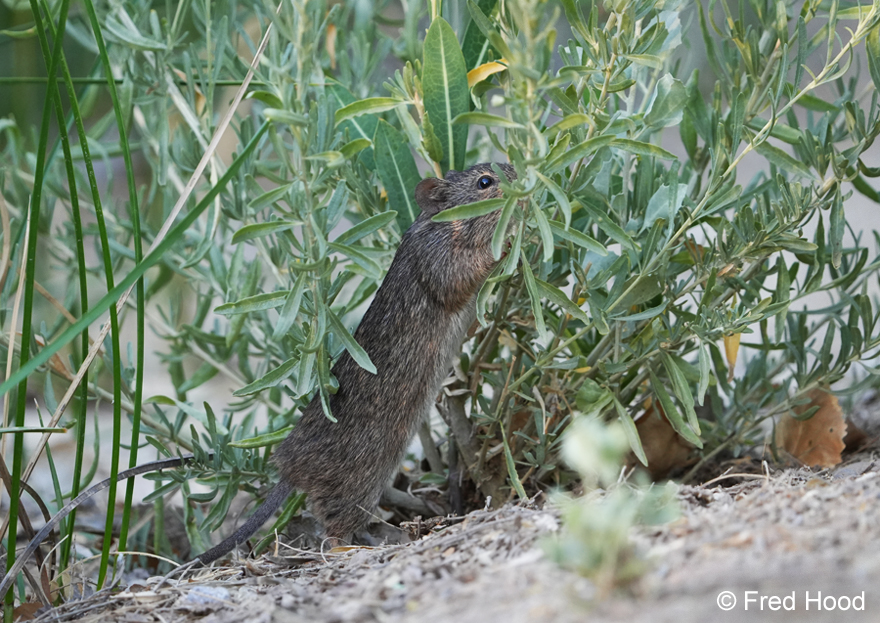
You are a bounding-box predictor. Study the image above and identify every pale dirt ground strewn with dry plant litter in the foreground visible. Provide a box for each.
[25,450,880,623]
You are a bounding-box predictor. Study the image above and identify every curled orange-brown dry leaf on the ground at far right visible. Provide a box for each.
[776,389,846,467]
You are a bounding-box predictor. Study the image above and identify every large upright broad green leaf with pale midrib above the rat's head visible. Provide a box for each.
[422,17,470,173]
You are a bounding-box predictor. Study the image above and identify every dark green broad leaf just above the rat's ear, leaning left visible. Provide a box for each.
[373,119,422,231]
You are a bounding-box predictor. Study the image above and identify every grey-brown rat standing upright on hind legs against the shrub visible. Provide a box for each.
[199,163,516,564]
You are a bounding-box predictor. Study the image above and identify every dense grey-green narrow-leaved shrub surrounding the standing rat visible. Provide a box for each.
[0,0,880,604]
